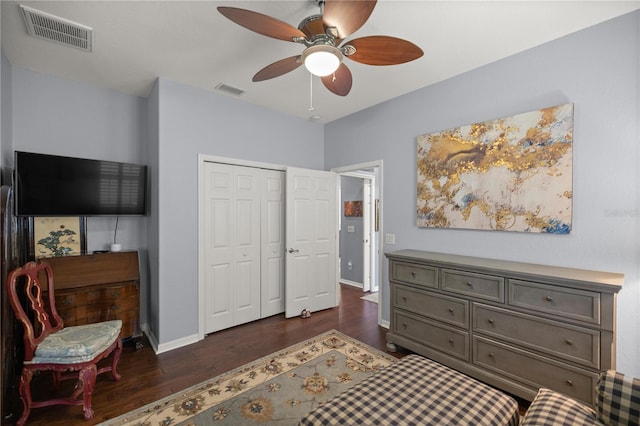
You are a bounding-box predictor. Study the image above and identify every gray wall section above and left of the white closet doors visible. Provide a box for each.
[150,78,324,343]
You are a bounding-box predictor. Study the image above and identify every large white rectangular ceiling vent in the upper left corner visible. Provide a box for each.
[20,5,93,52]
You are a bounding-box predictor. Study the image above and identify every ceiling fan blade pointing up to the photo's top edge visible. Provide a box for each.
[322,0,377,38]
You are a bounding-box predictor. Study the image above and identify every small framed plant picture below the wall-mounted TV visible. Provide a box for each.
[32,216,87,260]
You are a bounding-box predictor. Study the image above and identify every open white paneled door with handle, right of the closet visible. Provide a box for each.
[285,167,338,318]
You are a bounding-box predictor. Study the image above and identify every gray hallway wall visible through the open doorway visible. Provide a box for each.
[340,176,364,284]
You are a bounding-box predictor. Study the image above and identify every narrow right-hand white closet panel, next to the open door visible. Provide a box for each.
[261,170,285,318]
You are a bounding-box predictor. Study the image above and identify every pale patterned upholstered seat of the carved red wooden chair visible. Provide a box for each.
[25,320,122,364]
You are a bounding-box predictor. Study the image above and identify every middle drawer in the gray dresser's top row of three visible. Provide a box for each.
[442,269,504,302]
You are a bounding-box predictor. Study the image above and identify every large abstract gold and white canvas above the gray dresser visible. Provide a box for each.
[417,104,573,234]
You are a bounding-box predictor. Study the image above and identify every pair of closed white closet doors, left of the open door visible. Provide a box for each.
[202,162,284,333]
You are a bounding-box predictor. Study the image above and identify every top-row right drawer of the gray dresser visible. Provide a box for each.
[509,280,600,324]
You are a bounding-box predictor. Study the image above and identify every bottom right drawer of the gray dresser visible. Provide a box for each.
[473,336,598,404]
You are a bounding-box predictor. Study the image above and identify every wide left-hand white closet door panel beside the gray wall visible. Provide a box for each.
[204,163,260,333]
